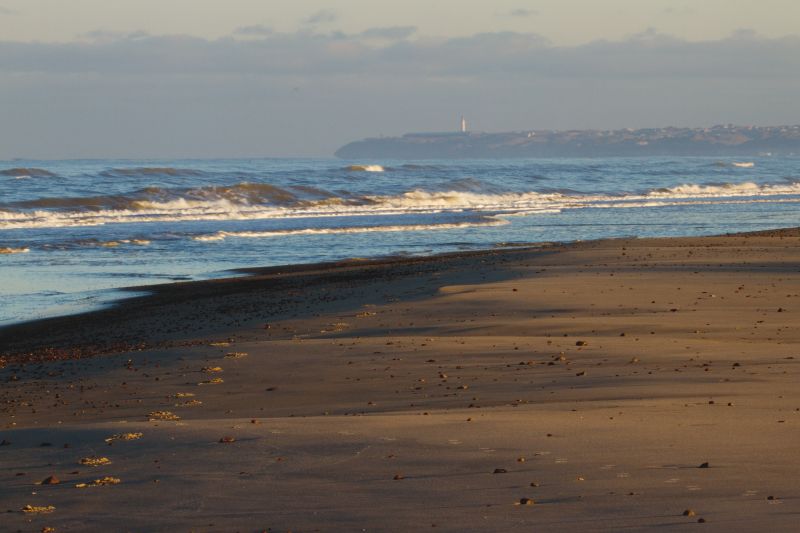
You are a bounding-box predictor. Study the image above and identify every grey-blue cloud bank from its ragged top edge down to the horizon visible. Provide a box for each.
[0,29,800,158]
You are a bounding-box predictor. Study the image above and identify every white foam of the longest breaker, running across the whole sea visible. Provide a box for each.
[6,182,800,229]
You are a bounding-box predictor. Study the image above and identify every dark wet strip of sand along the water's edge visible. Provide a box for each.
[0,227,800,361]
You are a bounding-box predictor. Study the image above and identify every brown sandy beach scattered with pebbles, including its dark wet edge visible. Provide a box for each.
[0,229,800,533]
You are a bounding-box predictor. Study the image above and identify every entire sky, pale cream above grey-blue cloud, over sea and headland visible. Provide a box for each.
[0,0,800,159]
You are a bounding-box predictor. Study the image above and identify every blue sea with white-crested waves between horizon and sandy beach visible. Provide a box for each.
[0,156,800,326]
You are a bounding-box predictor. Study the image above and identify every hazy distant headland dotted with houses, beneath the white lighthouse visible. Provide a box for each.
[336,126,800,159]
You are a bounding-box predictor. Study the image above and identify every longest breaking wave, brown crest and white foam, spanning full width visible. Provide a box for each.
[0,183,800,229]
